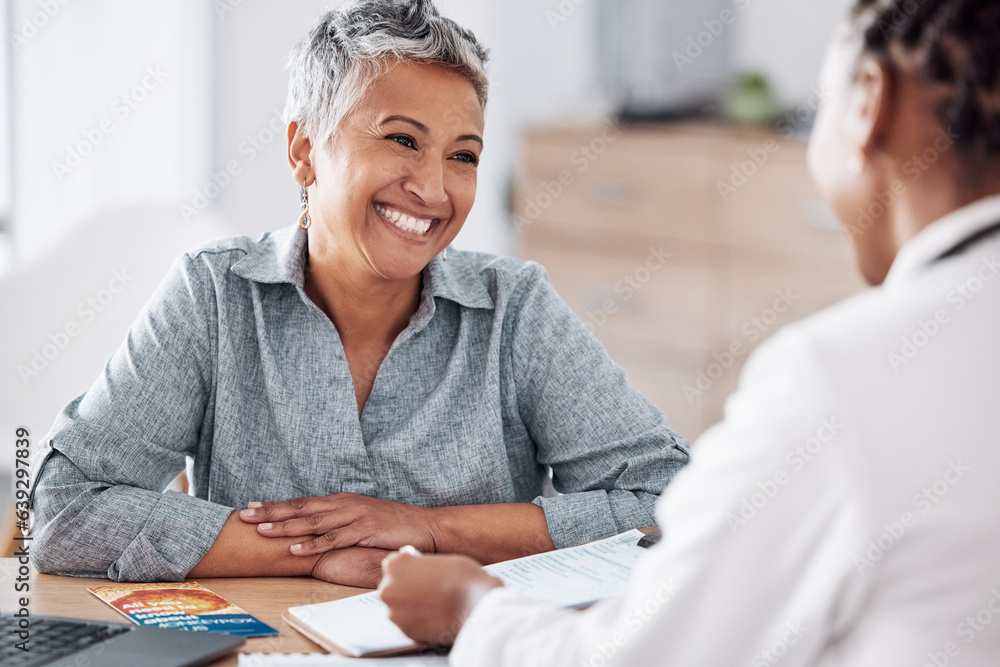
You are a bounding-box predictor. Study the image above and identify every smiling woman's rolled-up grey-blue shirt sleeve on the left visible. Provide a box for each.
[32,256,232,581]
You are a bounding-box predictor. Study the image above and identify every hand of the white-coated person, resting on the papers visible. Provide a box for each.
[378,553,503,646]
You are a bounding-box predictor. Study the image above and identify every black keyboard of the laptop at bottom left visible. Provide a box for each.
[0,616,133,667]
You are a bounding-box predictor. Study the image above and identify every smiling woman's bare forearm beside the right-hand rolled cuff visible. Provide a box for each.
[428,503,555,564]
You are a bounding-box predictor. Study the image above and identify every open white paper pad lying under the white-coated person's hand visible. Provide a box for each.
[282,530,646,657]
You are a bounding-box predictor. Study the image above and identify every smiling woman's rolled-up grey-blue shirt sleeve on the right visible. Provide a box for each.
[511,265,689,548]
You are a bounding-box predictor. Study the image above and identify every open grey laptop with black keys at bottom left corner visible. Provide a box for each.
[0,615,246,667]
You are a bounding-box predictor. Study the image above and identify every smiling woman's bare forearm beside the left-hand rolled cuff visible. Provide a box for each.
[188,512,319,577]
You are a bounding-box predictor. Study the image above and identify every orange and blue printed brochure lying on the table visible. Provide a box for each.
[87,581,280,637]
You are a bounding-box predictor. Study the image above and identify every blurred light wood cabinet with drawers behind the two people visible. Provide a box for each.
[512,126,864,439]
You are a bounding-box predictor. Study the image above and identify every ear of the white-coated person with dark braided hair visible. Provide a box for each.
[847,56,895,155]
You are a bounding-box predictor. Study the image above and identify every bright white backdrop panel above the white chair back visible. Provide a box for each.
[5,0,211,262]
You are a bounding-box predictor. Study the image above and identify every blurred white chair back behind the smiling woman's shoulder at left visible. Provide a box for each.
[0,205,231,464]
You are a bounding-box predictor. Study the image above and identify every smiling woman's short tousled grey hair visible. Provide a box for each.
[284,0,489,143]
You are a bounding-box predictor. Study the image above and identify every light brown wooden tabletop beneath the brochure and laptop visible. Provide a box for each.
[0,558,368,666]
